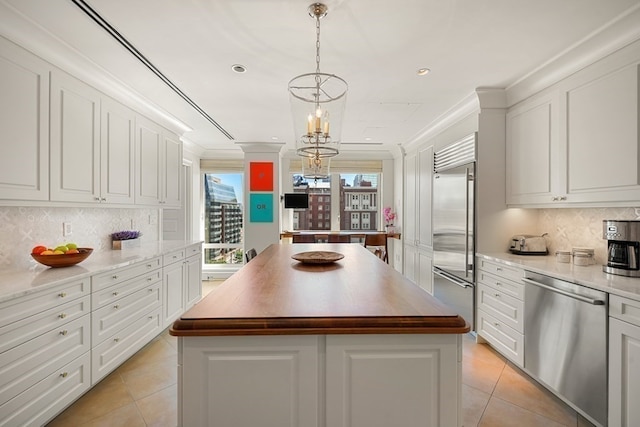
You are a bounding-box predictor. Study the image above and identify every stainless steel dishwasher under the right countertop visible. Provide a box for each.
[523,271,607,426]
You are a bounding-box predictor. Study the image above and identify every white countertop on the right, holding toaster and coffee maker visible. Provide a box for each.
[477,252,640,301]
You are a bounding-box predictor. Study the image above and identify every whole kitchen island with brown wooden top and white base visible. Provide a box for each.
[170,243,470,427]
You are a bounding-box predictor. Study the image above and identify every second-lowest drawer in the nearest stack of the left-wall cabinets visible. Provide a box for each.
[0,316,91,403]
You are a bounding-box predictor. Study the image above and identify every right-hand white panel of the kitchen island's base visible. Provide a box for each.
[326,334,462,427]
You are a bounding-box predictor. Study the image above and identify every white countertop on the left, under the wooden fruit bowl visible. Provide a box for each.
[0,240,202,302]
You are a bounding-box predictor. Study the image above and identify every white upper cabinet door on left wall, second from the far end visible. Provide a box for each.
[135,116,162,206]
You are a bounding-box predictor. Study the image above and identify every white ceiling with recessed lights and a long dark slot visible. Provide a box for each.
[0,0,640,157]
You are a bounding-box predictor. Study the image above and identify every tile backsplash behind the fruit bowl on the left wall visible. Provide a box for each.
[0,207,160,269]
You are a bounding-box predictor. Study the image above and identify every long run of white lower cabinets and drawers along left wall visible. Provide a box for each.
[0,244,202,427]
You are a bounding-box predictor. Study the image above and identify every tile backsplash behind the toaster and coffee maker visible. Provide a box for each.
[538,208,640,264]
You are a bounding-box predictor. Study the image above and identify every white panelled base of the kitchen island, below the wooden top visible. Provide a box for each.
[178,334,462,427]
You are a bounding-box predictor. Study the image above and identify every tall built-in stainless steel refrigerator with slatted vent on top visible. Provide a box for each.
[432,135,476,330]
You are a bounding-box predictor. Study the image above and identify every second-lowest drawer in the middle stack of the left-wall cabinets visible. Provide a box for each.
[91,281,162,346]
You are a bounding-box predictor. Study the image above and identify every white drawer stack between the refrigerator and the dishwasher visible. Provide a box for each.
[476,258,525,367]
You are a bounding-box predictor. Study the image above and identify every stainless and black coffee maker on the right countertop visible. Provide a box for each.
[602,220,640,277]
